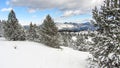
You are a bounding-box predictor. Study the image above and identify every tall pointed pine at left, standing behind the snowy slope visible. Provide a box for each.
[4,10,25,41]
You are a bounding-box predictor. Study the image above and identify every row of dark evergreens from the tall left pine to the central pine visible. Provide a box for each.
[3,10,60,48]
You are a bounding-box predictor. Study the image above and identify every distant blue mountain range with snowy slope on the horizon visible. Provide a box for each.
[56,22,96,32]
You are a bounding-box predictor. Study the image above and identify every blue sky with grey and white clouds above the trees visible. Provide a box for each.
[0,0,103,25]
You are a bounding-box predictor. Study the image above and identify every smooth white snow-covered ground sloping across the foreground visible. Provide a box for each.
[0,38,89,68]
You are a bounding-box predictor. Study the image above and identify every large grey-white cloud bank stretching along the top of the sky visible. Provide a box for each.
[9,0,103,16]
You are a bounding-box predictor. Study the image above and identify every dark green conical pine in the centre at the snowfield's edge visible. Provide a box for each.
[40,15,59,48]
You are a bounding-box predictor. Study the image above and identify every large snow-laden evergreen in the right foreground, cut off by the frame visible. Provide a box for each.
[91,0,120,68]
